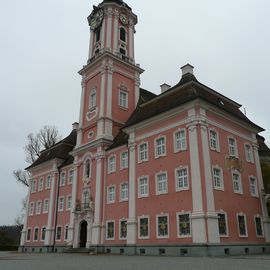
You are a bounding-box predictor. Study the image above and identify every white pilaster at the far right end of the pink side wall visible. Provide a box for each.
[253,145,270,242]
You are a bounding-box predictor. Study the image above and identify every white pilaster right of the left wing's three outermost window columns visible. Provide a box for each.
[44,173,57,246]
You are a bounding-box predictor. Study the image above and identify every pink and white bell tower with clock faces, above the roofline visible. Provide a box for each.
[77,0,143,147]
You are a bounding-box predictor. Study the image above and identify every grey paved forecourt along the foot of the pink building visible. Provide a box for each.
[0,252,270,270]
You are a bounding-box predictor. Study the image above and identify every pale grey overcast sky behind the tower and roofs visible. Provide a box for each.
[0,0,270,225]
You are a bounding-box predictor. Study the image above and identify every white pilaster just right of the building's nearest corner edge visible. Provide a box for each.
[201,123,220,243]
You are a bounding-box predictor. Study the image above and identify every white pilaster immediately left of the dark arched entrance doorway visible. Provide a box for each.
[67,165,78,246]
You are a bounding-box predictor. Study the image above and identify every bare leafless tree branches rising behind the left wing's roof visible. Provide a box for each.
[13,126,61,187]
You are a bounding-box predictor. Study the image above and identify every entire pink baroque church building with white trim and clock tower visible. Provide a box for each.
[20,0,270,256]
